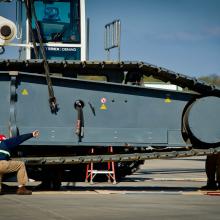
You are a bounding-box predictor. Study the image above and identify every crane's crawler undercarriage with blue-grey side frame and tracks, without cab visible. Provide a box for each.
[0,60,220,188]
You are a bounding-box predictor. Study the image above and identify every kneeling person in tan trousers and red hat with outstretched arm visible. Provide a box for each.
[0,130,40,195]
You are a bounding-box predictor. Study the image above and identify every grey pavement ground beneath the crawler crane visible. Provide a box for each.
[0,158,220,220]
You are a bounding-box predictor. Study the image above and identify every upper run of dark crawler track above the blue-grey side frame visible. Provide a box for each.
[0,60,220,97]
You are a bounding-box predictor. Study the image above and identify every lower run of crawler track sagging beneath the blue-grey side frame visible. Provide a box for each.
[13,147,220,166]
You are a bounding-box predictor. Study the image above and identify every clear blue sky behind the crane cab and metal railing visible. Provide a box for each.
[0,0,220,76]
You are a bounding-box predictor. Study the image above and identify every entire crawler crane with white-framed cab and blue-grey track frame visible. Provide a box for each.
[0,0,220,188]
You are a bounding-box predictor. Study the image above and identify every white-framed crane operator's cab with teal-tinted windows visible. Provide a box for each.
[22,0,86,60]
